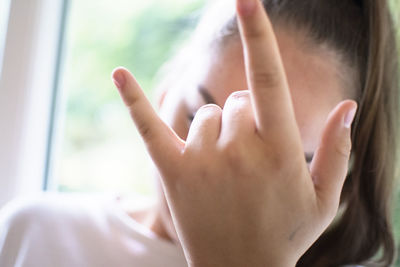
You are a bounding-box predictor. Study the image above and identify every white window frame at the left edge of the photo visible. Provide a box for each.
[0,0,67,207]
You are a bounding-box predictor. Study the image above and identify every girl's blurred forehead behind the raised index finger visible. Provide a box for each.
[188,28,349,154]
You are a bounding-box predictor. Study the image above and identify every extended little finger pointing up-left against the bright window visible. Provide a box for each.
[112,67,184,178]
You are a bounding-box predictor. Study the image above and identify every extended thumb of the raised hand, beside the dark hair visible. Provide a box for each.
[310,100,357,214]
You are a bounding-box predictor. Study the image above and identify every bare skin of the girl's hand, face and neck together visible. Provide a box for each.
[113,1,356,266]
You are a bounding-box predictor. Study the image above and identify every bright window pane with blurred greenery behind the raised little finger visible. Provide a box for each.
[53,0,204,199]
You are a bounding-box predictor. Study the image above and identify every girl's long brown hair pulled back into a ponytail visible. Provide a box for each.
[155,0,399,267]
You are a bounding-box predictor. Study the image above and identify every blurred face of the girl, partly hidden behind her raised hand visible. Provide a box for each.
[155,26,350,244]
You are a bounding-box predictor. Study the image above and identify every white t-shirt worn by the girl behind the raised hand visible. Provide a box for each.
[0,194,187,267]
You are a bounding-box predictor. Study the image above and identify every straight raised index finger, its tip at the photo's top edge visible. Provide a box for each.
[236,0,297,136]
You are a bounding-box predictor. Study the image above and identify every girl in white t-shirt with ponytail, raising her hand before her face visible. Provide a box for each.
[0,0,398,266]
